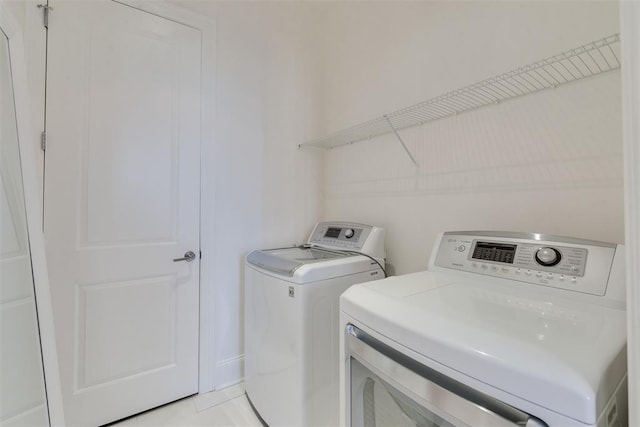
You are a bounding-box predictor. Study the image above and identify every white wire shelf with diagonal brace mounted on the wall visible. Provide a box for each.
[299,34,620,159]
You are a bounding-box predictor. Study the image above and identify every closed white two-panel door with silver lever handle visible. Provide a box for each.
[44,0,201,426]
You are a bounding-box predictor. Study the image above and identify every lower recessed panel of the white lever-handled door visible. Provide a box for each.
[76,277,176,390]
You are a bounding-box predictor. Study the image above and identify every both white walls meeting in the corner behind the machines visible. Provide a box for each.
[177,0,624,388]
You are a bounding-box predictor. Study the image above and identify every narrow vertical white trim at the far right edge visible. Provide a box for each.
[620,1,640,426]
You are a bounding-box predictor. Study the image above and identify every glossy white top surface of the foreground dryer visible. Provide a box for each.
[340,272,626,424]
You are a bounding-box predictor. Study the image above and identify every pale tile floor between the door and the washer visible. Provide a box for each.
[110,384,262,427]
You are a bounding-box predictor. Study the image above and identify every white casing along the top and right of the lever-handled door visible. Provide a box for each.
[113,0,216,393]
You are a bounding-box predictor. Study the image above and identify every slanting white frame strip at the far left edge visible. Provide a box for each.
[0,2,65,427]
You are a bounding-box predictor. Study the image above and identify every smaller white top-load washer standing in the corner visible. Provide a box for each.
[244,222,385,427]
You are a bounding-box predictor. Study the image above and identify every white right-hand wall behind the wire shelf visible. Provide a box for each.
[320,2,624,274]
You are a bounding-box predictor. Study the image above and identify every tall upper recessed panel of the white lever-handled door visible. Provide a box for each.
[81,22,180,246]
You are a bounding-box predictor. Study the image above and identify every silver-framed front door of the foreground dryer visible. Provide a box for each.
[347,325,547,427]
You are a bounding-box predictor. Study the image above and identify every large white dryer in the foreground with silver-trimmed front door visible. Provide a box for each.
[340,231,628,427]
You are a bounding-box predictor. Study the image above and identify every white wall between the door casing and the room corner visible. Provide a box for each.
[177,1,322,388]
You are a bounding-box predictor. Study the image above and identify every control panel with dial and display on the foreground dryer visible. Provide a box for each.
[432,232,616,295]
